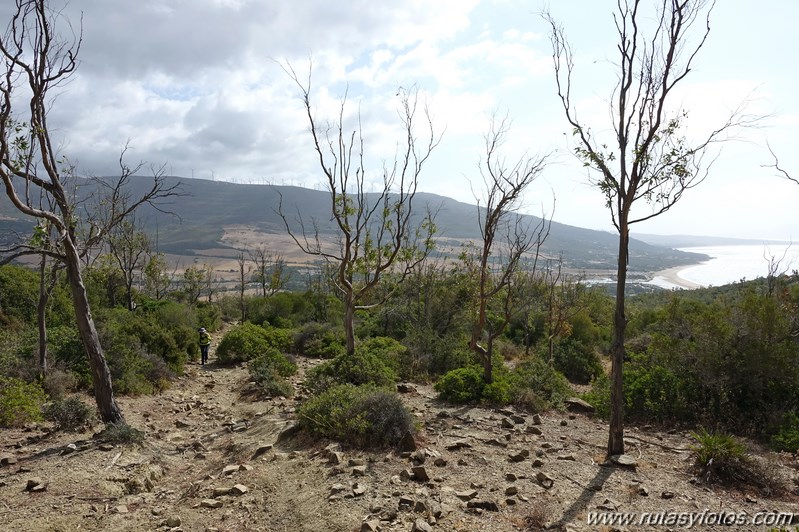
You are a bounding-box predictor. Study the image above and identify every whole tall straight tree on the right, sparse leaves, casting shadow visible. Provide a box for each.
[544,0,756,456]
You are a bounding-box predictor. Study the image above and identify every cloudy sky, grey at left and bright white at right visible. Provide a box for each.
[0,0,799,241]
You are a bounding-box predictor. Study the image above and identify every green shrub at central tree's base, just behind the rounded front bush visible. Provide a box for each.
[306,349,397,393]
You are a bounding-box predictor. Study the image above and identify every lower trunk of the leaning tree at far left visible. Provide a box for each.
[64,239,125,423]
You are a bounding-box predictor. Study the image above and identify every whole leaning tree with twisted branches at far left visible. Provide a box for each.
[0,0,178,423]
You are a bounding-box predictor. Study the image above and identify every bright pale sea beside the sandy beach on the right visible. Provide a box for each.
[650,244,799,288]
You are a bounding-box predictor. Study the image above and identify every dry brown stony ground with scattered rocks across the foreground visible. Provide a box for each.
[0,338,799,532]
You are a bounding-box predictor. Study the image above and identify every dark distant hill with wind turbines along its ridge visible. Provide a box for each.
[0,177,708,272]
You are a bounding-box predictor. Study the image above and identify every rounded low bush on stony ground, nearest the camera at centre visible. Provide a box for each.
[297,384,415,448]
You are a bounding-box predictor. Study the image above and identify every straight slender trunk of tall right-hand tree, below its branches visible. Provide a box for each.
[608,222,630,456]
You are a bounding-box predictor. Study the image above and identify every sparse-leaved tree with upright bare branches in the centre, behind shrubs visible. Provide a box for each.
[279,66,441,354]
